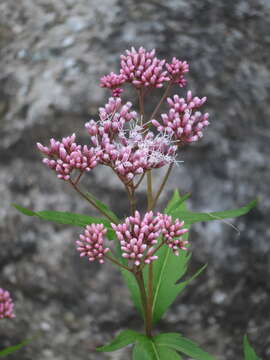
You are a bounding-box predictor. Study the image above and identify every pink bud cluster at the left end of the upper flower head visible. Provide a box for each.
[37,134,99,180]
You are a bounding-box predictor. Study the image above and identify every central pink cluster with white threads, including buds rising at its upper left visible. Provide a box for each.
[85,98,177,181]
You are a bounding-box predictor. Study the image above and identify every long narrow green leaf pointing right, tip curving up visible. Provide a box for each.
[171,200,257,225]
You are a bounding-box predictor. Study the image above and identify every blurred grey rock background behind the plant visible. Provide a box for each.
[0,0,270,360]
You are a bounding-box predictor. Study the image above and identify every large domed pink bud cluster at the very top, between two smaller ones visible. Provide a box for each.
[120,47,169,88]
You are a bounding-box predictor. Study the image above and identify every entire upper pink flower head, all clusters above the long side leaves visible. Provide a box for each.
[37,47,209,183]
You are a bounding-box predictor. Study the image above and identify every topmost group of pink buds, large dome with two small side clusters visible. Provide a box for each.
[100,47,189,97]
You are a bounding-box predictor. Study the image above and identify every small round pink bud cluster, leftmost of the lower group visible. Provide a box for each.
[76,224,110,264]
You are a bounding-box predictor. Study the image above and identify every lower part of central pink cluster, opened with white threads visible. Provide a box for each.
[92,123,177,181]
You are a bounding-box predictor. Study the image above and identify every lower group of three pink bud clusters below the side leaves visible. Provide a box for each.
[77,211,188,267]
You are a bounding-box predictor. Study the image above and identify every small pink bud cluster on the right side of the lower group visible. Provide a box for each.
[158,213,188,256]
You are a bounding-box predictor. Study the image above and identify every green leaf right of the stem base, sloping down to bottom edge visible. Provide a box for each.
[154,333,215,360]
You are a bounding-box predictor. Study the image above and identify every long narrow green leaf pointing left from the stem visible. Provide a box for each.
[13,204,115,240]
